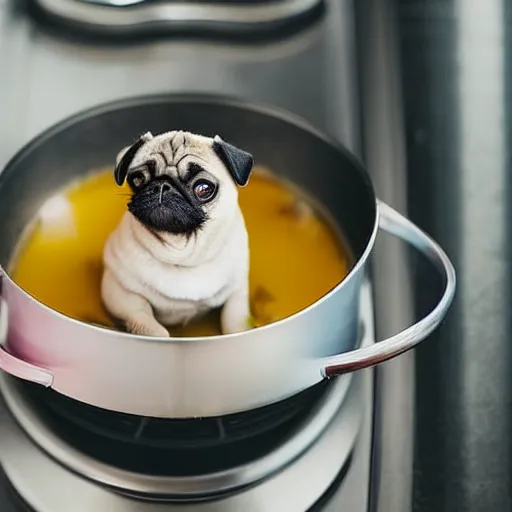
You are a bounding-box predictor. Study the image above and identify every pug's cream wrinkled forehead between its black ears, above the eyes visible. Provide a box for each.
[130,131,218,175]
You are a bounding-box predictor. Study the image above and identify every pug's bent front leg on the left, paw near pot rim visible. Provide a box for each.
[101,270,169,338]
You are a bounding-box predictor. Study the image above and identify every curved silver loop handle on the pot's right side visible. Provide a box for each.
[322,201,456,377]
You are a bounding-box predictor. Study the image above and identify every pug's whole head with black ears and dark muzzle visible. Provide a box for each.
[114,131,253,236]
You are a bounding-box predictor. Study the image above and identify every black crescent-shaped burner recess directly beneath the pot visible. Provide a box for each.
[20,381,331,477]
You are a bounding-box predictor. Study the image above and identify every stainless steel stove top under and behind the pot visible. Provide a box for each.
[0,0,414,512]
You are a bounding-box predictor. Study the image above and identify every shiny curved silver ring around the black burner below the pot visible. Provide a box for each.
[0,358,352,500]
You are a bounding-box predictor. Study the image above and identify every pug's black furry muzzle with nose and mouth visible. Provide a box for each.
[128,178,206,235]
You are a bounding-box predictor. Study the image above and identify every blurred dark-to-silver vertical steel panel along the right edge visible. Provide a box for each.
[397,0,512,512]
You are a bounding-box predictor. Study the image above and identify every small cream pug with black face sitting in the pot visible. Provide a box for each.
[101,131,254,337]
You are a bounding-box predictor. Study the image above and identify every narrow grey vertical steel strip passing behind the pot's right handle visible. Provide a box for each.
[358,0,416,512]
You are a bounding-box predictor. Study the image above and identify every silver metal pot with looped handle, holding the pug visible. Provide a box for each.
[0,95,455,418]
